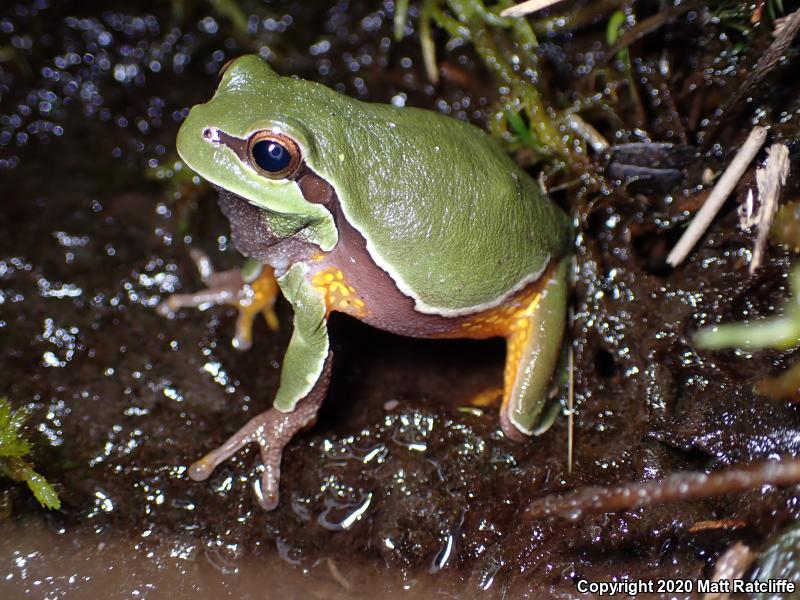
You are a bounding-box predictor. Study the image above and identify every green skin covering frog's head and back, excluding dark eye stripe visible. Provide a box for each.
[178,56,571,316]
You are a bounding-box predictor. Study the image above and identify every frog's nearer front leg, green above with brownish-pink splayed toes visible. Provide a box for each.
[189,263,333,510]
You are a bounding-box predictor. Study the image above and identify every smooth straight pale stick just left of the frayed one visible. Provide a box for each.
[667,125,767,267]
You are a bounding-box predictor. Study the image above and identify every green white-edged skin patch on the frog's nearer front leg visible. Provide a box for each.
[273,263,330,412]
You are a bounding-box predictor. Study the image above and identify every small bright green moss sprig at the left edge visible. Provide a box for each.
[0,398,61,509]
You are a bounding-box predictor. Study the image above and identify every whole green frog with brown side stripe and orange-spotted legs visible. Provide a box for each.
[164,55,573,510]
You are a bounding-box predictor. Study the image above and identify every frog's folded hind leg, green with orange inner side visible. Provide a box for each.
[500,260,568,440]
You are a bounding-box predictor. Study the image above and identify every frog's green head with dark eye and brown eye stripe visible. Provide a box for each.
[177,56,338,258]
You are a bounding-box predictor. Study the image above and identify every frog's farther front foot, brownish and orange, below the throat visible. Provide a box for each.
[157,248,279,350]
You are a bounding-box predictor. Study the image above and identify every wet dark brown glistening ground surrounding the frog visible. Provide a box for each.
[0,0,800,598]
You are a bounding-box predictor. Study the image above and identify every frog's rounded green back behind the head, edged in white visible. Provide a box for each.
[310,95,569,314]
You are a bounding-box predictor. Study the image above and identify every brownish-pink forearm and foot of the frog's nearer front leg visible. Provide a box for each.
[189,354,331,510]
